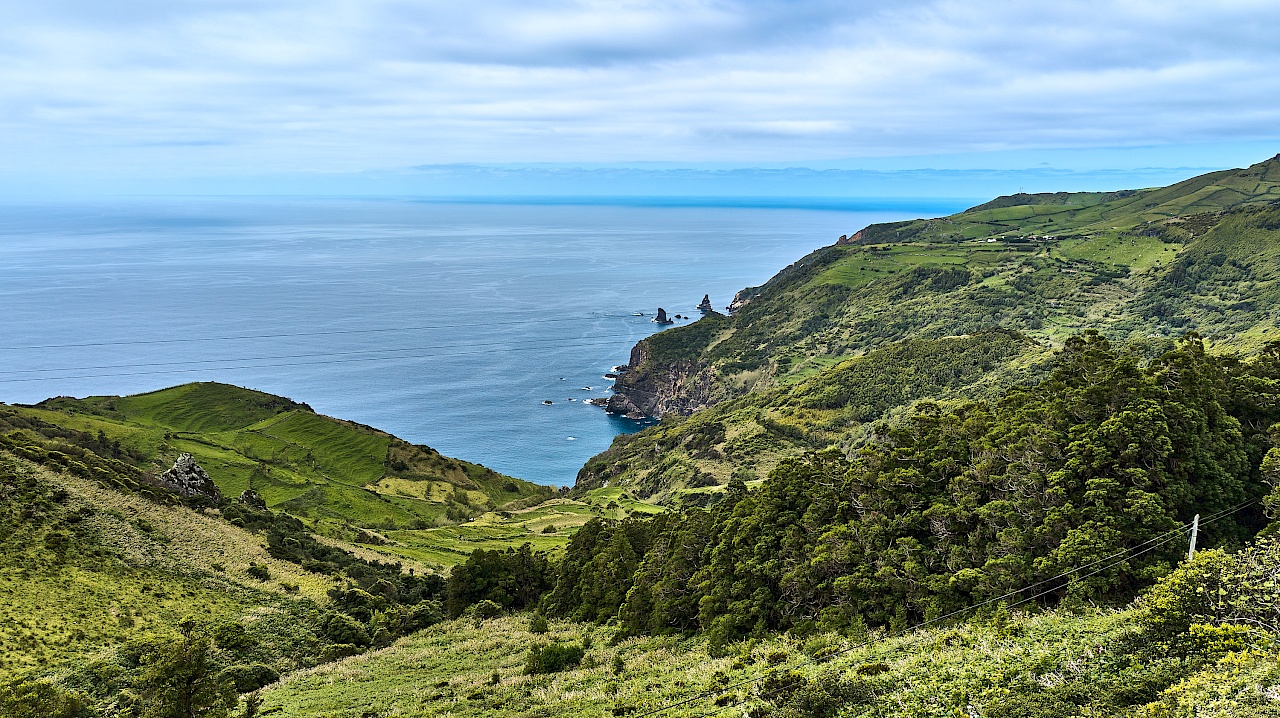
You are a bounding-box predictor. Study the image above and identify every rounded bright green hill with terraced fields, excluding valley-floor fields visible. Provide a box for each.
[13,383,549,538]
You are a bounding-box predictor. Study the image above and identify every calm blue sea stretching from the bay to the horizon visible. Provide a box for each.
[0,198,955,484]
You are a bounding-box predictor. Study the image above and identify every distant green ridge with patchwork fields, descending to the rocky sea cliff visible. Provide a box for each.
[614,151,1280,416]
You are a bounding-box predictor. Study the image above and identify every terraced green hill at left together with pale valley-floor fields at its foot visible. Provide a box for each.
[0,384,658,570]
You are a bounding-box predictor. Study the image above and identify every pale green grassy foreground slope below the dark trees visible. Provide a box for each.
[264,563,1280,718]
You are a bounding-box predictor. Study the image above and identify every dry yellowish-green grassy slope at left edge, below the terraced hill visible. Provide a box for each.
[0,452,329,678]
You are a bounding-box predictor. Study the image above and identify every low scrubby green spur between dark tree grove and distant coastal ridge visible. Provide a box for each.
[577,331,1046,502]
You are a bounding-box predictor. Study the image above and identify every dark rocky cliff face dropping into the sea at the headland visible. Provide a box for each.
[605,340,716,419]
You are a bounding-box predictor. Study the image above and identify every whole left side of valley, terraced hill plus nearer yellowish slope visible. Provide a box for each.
[0,384,662,718]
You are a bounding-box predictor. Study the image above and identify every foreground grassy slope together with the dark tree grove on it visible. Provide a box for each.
[254,335,1280,718]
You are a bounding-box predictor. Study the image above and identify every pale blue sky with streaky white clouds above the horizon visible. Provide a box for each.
[0,0,1280,196]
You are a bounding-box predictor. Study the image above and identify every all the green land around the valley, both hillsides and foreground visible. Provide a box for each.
[0,157,1280,718]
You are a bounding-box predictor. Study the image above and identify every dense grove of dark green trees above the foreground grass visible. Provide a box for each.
[449,334,1280,645]
